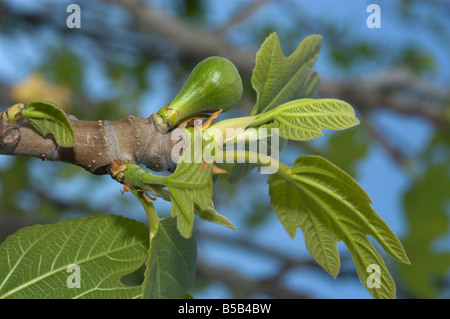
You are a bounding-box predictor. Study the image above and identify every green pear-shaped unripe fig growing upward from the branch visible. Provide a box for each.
[155,57,242,129]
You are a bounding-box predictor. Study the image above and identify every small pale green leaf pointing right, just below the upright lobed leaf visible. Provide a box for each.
[252,99,359,141]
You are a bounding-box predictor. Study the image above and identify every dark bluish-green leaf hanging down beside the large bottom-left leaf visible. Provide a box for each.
[142,217,197,299]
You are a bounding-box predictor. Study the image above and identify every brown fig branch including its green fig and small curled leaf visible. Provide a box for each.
[0,57,242,175]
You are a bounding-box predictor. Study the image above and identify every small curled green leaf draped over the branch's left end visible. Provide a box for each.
[22,100,75,147]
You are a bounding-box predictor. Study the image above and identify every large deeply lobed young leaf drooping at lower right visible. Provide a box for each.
[268,156,409,298]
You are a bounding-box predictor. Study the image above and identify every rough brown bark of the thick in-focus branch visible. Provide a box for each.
[0,116,183,175]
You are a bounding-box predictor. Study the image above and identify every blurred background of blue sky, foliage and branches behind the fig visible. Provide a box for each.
[0,0,450,298]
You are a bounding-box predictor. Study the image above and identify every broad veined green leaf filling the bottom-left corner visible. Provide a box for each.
[0,215,149,299]
